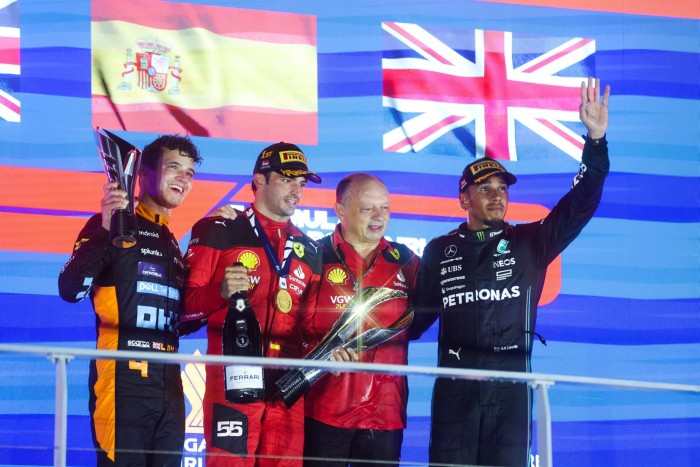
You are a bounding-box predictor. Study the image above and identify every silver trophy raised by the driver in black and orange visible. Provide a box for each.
[93,127,141,248]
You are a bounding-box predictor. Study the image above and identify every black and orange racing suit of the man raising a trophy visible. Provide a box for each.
[58,204,185,466]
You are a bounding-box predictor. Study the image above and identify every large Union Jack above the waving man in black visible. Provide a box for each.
[382,22,595,161]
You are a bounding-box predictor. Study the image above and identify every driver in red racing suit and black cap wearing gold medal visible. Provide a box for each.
[181,143,321,467]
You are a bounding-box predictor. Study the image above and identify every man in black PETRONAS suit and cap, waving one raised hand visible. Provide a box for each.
[409,78,610,466]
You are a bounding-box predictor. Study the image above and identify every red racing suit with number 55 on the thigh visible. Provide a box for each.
[182,207,321,467]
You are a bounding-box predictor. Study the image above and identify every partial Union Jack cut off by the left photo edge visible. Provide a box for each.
[0,0,20,122]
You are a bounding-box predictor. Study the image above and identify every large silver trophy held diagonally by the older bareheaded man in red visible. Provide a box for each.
[275,287,413,407]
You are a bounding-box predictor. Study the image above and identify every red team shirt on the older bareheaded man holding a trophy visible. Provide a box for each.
[304,227,419,430]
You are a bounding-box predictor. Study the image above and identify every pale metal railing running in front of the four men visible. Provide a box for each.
[0,344,700,467]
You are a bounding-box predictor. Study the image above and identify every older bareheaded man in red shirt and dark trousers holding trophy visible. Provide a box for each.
[304,173,419,467]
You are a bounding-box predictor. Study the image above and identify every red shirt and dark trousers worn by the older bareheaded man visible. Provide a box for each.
[304,230,419,466]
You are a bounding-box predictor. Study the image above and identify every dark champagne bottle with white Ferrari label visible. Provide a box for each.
[222,292,265,404]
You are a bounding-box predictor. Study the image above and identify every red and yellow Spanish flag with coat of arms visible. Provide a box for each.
[92,0,318,144]
